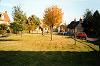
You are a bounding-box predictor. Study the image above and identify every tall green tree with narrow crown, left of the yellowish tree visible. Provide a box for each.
[12,6,27,34]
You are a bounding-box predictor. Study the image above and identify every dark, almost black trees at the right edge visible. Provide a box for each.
[83,10,100,38]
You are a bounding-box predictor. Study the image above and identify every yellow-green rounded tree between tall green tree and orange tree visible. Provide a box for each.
[26,15,40,33]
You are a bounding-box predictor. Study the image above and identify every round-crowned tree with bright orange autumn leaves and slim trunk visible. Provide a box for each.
[43,6,63,40]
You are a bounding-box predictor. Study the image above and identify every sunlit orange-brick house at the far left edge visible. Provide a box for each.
[0,11,10,25]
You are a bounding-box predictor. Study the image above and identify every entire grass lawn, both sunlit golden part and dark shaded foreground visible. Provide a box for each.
[0,34,100,66]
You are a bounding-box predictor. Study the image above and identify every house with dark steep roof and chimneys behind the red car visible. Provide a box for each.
[67,18,84,33]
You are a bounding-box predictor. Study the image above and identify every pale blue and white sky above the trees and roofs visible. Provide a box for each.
[0,0,100,24]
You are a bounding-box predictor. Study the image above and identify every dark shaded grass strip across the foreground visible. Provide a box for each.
[0,51,100,66]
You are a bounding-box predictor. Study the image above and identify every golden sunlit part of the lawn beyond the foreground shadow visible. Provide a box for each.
[0,34,99,52]
